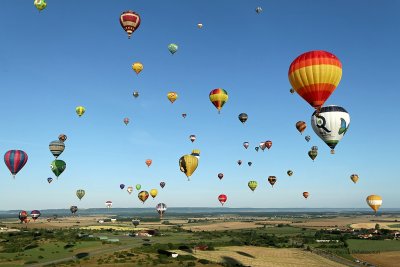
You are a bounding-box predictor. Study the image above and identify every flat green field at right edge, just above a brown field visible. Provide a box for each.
[347,239,400,253]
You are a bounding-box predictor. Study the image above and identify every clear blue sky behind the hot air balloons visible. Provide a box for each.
[0,0,400,210]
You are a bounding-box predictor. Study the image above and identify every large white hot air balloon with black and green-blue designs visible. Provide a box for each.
[311,105,350,154]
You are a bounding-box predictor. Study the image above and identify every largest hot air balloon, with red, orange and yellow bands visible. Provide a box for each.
[288,50,342,110]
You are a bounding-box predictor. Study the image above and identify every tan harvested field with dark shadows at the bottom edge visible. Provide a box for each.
[176,246,344,267]
